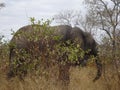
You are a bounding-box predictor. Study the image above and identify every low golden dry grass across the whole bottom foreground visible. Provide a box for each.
[0,66,120,90]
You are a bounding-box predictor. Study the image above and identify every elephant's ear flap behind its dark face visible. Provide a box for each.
[70,27,85,50]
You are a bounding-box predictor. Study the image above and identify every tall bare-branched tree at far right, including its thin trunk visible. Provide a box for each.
[85,0,120,84]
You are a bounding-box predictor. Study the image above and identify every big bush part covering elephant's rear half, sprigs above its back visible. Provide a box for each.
[9,18,53,76]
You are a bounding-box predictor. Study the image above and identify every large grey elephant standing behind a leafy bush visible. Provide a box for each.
[7,25,102,89]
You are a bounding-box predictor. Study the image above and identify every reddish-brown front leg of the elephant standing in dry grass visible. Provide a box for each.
[58,64,70,90]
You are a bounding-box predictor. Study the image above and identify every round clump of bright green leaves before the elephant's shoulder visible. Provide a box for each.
[54,40,85,64]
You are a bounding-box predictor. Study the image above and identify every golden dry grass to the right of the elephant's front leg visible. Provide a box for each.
[70,67,120,90]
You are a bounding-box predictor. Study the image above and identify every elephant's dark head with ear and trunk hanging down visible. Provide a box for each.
[70,27,102,82]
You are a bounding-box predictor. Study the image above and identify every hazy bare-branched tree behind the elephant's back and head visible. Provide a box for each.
[54,10,96,35]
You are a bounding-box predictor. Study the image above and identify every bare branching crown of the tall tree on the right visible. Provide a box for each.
[86,0,120,50]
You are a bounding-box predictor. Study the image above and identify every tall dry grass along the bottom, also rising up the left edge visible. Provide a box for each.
[0,41,120,90]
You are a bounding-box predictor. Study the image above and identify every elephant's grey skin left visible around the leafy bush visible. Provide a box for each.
[8,25,102,87]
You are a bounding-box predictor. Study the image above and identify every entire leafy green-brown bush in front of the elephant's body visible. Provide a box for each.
[9,18,89,76]
